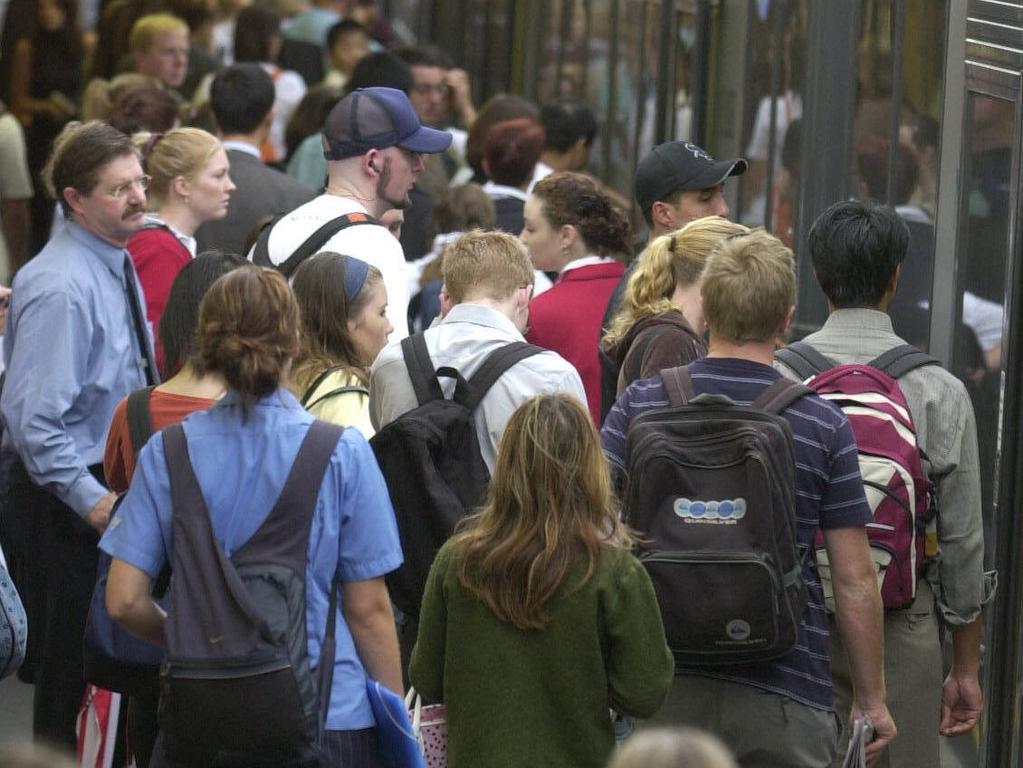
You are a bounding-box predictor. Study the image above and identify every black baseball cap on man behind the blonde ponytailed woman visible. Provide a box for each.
[635,141,749,211]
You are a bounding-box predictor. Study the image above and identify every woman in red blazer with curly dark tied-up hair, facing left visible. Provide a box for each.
[521,172,629,424]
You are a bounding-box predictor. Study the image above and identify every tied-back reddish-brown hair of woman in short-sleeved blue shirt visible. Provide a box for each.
[198,265,299,404]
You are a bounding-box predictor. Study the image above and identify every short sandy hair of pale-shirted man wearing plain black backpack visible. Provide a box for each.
[443,229,535,304]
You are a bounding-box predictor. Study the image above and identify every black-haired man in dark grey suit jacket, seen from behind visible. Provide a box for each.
[195,63,316,255]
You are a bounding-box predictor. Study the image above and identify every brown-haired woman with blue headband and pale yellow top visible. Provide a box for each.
[292,252,393,438]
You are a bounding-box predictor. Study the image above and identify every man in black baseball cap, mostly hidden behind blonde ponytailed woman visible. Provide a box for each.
[599,141,749,420]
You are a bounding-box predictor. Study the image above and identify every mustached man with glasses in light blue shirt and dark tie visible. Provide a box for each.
[0,122,157,749]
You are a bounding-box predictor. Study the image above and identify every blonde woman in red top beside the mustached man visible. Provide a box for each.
[128,128,234,359]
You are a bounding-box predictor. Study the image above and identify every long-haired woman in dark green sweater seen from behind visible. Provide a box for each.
[409,395,674,768]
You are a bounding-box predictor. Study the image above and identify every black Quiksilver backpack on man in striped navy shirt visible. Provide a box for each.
[624,367,810,666]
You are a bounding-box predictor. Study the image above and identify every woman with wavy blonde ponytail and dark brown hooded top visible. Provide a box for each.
[601,216,750,396]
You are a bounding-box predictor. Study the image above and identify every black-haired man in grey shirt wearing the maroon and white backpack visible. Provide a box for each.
[775,201,994,766]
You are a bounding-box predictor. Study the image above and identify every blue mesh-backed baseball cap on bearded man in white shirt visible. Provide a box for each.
[323,87,451,160]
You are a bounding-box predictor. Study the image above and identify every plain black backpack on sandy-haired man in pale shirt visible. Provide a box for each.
[369,333,543,618]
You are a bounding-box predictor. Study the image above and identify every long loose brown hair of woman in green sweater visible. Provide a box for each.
[452,394,632,629]
